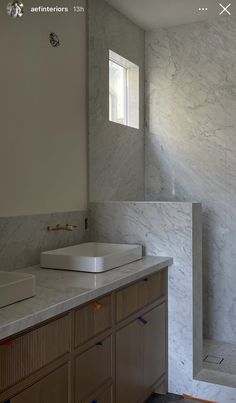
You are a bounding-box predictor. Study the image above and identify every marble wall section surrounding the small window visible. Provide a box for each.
[88,0,145,201]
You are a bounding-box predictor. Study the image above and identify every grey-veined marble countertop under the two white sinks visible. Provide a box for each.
[0,256,173,340]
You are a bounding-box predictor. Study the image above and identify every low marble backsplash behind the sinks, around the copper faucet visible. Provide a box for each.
[0,210,89,271]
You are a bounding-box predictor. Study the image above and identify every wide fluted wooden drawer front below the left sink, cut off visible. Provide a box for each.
[0,315,70,391]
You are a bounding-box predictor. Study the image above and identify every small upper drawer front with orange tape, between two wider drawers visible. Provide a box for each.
[75,295,112,347]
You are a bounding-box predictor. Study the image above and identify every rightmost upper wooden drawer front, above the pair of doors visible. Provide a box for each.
[116,270,167,322]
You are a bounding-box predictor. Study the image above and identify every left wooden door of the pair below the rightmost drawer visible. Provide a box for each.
[116,320,144,403]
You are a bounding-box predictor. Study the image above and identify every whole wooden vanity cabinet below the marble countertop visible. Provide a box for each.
[0,269,167,403]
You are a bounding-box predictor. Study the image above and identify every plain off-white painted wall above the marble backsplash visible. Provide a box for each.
[0,0,87,216]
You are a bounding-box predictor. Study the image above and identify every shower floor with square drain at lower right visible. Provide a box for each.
[203,340,236,374]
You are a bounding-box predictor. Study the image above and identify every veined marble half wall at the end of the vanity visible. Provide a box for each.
[90,202,202,400]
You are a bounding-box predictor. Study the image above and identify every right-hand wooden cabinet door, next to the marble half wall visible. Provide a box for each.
[143,303,166,388]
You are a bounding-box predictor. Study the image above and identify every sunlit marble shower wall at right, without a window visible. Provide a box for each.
[145,16,236,342]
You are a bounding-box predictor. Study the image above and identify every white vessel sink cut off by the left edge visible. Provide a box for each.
[0,271,35,308]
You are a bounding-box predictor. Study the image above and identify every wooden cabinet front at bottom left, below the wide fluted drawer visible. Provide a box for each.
[9,364,69,403]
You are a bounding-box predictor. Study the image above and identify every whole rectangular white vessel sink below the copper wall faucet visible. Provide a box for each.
[41,242,142,273]
